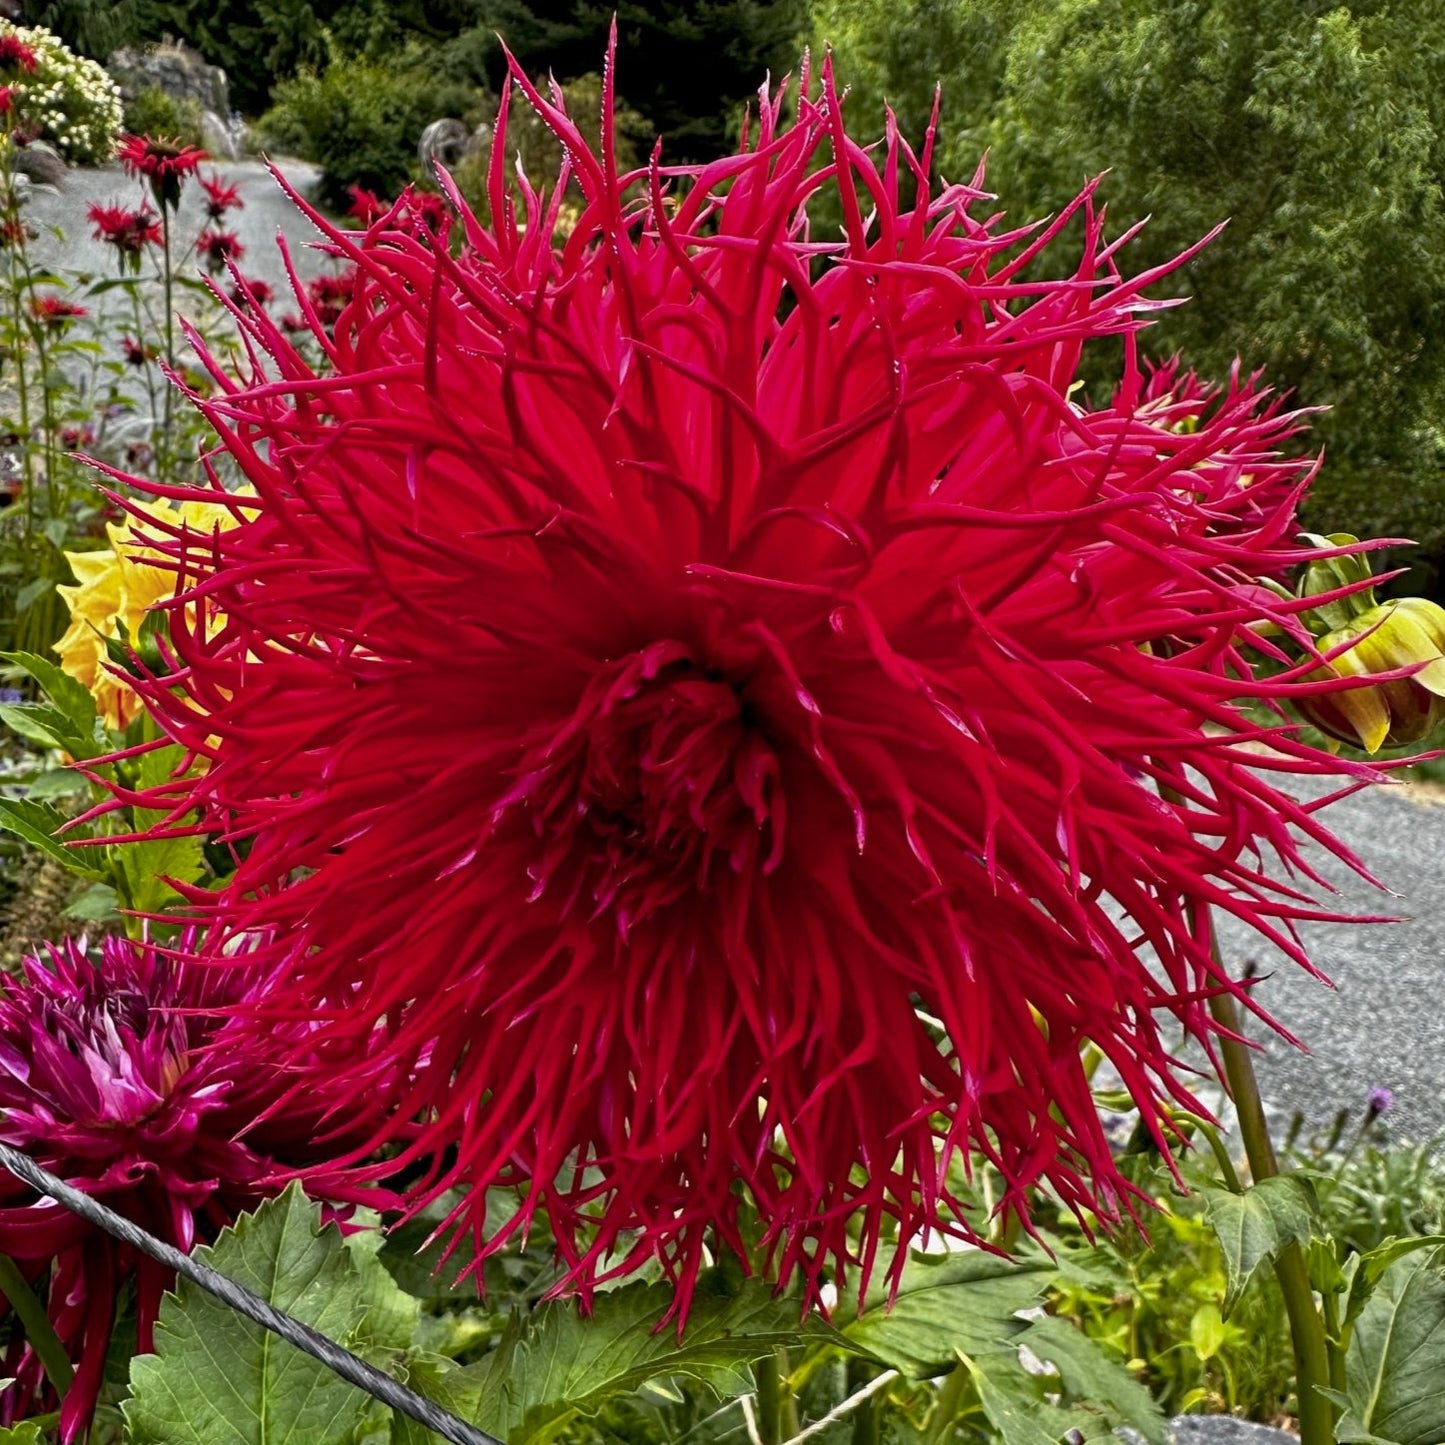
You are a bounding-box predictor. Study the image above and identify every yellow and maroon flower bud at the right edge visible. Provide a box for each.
[1299,597,1445,753]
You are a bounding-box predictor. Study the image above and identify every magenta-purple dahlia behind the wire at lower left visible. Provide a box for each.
[0,938,367,1445]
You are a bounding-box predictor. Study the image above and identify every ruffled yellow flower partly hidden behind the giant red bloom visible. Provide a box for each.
[55,501,236,730]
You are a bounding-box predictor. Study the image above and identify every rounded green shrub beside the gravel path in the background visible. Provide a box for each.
[249,42,481,208]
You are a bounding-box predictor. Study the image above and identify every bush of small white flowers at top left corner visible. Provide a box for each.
[0,22,123,165]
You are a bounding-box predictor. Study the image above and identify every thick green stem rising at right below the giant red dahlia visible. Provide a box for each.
[1209,994,1335,1445]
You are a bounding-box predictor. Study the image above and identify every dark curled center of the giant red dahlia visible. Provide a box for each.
[509,642,783,932]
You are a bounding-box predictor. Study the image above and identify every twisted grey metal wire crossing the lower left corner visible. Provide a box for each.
[0,1144,503,1445]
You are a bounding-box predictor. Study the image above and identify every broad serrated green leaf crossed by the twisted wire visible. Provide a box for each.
[121,1183,371,1445]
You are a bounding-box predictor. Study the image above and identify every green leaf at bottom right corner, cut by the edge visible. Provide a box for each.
[1335,1247,1445,1445]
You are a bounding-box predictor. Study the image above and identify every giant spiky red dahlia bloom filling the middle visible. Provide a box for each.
[127,62,1374,1311]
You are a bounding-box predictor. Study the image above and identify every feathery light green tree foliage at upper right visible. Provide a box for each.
[815,0,1445,590]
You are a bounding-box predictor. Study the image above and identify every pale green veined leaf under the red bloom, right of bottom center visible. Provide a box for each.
[841,1250,1056,1380]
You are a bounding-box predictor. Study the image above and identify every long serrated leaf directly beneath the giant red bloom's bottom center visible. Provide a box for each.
[465,1280,832,1445]
